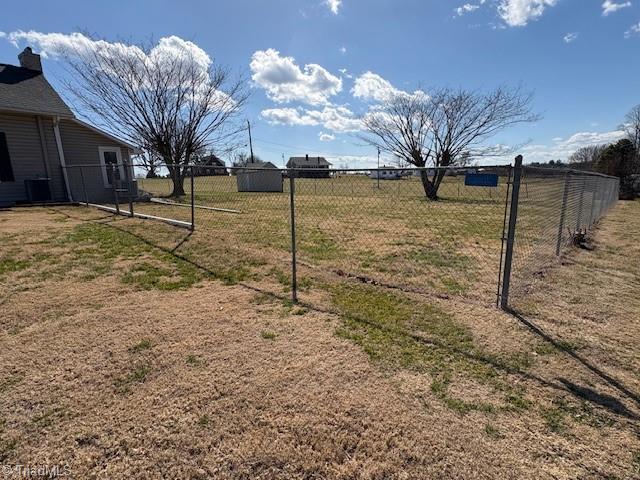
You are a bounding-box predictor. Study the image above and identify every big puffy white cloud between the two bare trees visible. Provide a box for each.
[249,48,342,105]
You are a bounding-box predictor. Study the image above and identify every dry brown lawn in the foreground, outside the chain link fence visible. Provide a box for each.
[0,202,640,479]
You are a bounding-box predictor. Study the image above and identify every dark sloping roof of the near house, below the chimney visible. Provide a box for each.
[0,63,73,117]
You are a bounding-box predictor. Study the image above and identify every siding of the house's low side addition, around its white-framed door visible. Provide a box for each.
[60,120,133,203]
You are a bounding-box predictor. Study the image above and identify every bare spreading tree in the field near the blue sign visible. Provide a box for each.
[362,87,539,200]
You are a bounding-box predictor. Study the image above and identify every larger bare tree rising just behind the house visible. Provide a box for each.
[64,35,247,196]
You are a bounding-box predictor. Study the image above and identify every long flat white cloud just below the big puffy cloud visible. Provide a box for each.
[261,106,362,132]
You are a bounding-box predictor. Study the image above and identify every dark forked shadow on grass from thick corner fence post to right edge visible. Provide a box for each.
[507,309,640,419]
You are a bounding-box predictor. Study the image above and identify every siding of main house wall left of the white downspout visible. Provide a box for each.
[0,113,65,204]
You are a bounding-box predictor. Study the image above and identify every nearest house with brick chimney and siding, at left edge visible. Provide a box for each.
[0,47,137,206]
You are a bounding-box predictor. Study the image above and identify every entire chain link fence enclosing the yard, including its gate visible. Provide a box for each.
[61,158,618,308]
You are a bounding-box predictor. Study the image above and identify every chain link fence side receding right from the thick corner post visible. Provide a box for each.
[499,157,620,308]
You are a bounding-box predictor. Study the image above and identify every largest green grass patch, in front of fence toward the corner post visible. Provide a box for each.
[328,283,531,413]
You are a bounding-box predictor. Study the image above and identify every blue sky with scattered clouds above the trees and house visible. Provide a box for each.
[0,0,640,167]
